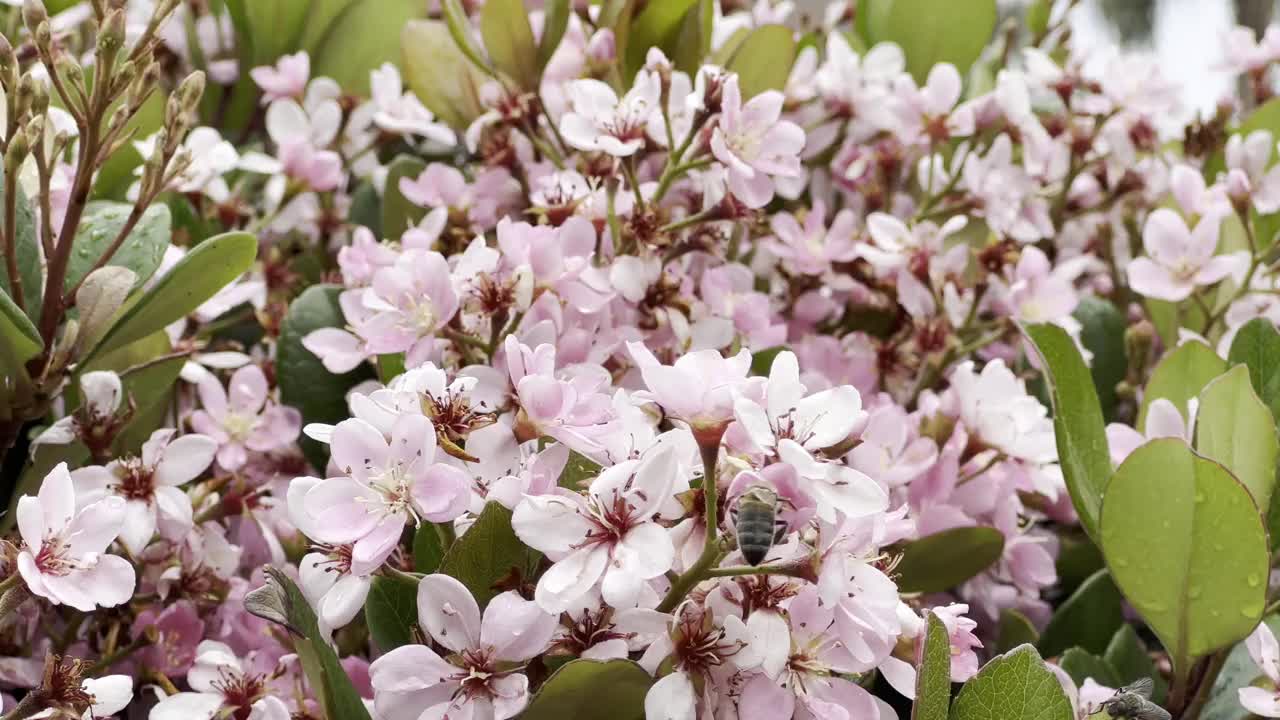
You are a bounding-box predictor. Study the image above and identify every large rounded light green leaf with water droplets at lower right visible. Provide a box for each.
[1102,438,1270,673]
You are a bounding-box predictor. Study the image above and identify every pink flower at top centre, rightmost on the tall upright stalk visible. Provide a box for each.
[712,74,804,208]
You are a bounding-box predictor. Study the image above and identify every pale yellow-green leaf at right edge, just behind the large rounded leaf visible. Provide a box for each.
[1196,365,1280,509]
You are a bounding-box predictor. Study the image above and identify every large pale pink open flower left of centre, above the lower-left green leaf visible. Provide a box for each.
[302,415,471,568]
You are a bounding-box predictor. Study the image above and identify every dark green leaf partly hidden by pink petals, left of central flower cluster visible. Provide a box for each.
[275,284,374,468]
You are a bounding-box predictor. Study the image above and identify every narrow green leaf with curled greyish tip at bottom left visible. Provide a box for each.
[244,568,370,720]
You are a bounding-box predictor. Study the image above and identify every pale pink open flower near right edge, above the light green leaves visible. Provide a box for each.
[1128,208,1249,302]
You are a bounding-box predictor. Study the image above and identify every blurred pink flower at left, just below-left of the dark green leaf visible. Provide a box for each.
[191,365,302,471]
